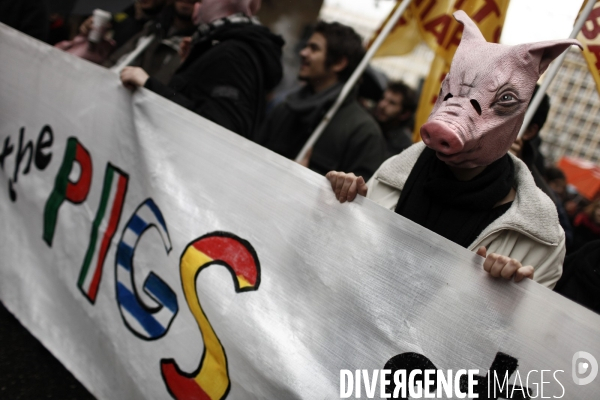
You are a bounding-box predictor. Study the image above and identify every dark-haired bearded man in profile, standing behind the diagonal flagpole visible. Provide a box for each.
[258,21,385,177]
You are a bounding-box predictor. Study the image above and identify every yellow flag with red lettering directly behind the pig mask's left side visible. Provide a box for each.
[412,0,509,142]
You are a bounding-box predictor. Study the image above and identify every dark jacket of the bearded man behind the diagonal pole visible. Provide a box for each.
[258,83,386,181]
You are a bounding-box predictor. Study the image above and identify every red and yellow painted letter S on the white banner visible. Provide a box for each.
[161,232,260,400]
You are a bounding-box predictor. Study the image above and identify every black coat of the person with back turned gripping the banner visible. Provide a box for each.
[145,19,284,139]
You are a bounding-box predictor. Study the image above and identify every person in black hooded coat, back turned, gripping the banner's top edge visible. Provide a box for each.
[121,0,284,140]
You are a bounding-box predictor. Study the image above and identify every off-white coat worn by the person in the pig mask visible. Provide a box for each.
[367,142,565,288]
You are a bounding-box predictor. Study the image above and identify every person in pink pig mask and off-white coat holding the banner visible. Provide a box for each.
[327,11,579,288]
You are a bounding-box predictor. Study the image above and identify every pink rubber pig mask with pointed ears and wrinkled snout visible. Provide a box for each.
[421,11,581,168]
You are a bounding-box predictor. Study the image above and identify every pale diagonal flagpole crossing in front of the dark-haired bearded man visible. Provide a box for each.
[296,0,412,162]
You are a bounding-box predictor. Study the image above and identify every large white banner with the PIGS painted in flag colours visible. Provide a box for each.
[0,26,600,399]
